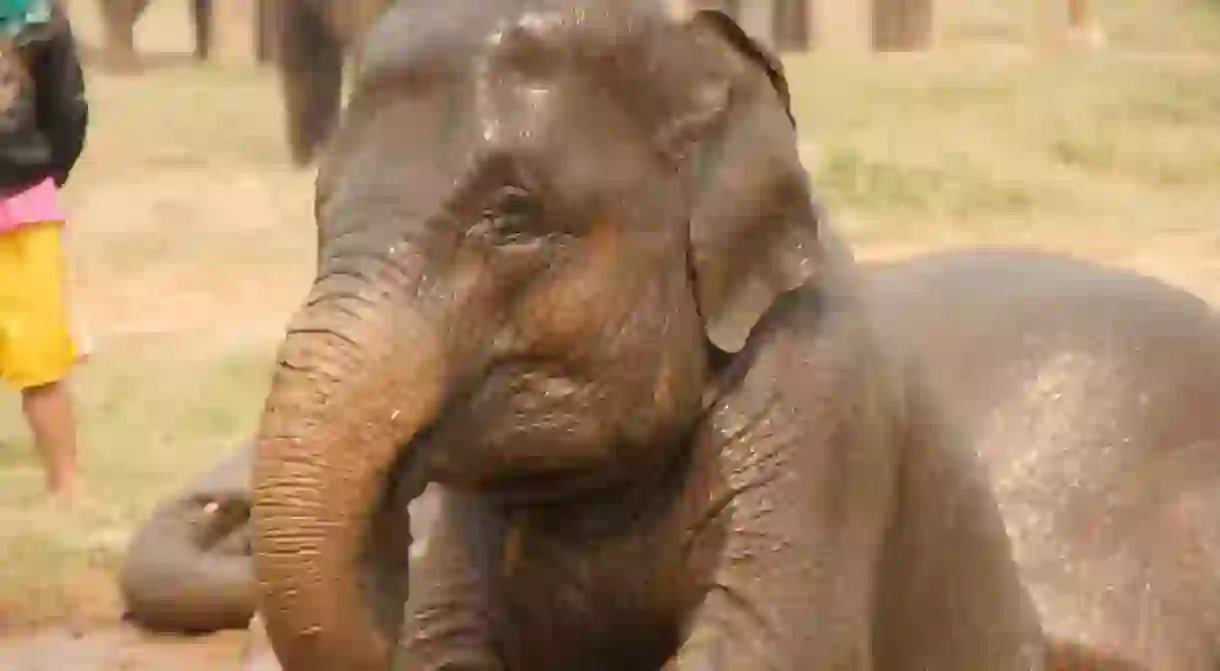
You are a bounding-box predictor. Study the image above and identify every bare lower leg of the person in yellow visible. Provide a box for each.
[21,378,78,500]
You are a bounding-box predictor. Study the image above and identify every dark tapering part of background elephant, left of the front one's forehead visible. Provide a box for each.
[267,0,393,166]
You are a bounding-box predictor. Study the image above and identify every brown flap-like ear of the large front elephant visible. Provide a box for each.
[664,10,821,353]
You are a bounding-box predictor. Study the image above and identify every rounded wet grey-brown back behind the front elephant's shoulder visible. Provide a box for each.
[869,250,1220,671]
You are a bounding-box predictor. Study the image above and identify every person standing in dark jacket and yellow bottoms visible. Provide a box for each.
[0,0,89,500]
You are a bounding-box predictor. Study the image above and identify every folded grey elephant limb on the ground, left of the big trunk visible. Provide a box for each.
[120,447,255,632]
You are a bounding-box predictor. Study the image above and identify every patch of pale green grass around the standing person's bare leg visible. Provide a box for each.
[0,337,270,631]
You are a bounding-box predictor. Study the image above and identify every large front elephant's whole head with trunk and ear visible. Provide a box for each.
[251,0,824,671]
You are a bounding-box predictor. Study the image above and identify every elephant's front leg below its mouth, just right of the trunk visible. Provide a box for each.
[393,489,504,671]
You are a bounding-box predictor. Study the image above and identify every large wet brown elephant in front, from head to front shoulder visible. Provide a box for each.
[251,0,1043,671]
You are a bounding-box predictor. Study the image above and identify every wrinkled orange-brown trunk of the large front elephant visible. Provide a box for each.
[251,268,456,671]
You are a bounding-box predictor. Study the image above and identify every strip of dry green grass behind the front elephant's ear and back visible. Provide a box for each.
[787,52,1220,243]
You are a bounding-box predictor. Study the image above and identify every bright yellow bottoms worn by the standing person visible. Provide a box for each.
[0,221,77,389]
